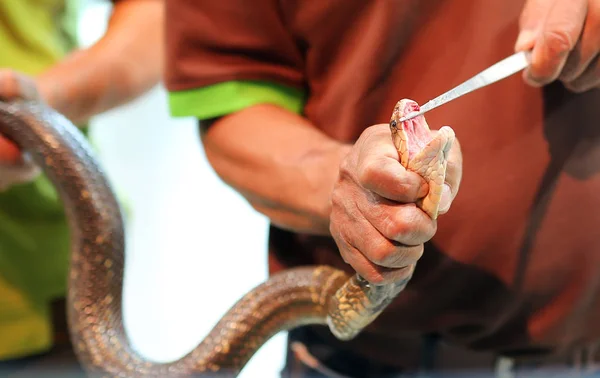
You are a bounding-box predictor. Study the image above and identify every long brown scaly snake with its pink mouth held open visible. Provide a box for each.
[0,99,454,377]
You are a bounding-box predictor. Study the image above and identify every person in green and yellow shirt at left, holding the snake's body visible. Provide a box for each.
[0,0,164,376]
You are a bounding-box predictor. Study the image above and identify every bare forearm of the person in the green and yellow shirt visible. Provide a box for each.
[36,0,164,123]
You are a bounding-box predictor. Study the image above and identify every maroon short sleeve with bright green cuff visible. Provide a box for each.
[165,0,305,119]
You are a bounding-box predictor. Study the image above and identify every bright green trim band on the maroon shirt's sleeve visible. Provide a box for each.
[168,80,304,119]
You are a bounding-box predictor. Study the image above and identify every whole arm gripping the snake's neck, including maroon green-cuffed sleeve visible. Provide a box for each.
[166,0,462,283]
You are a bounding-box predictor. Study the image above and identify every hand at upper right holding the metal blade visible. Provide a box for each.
[515,0,600,92]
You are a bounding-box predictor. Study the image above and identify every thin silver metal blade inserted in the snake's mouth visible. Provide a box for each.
[400,51,530,122]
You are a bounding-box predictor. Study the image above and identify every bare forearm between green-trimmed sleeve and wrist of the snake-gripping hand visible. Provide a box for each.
[202,105,350,235]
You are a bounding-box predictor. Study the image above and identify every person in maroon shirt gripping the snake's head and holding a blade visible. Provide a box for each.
[165,0,600,378]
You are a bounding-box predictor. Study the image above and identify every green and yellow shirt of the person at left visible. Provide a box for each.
[0,0,80,360]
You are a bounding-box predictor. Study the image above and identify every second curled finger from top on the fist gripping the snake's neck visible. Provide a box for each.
[357,196,437,246]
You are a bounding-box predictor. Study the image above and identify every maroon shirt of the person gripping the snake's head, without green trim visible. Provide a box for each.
[167,0,600,370]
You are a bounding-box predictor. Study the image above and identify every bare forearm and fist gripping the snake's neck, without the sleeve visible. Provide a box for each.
[202,104,461,283]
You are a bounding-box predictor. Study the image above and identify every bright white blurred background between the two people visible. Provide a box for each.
[79,0,285,378]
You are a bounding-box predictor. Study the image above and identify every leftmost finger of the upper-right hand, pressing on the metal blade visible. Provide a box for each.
[523,0,587,86]
